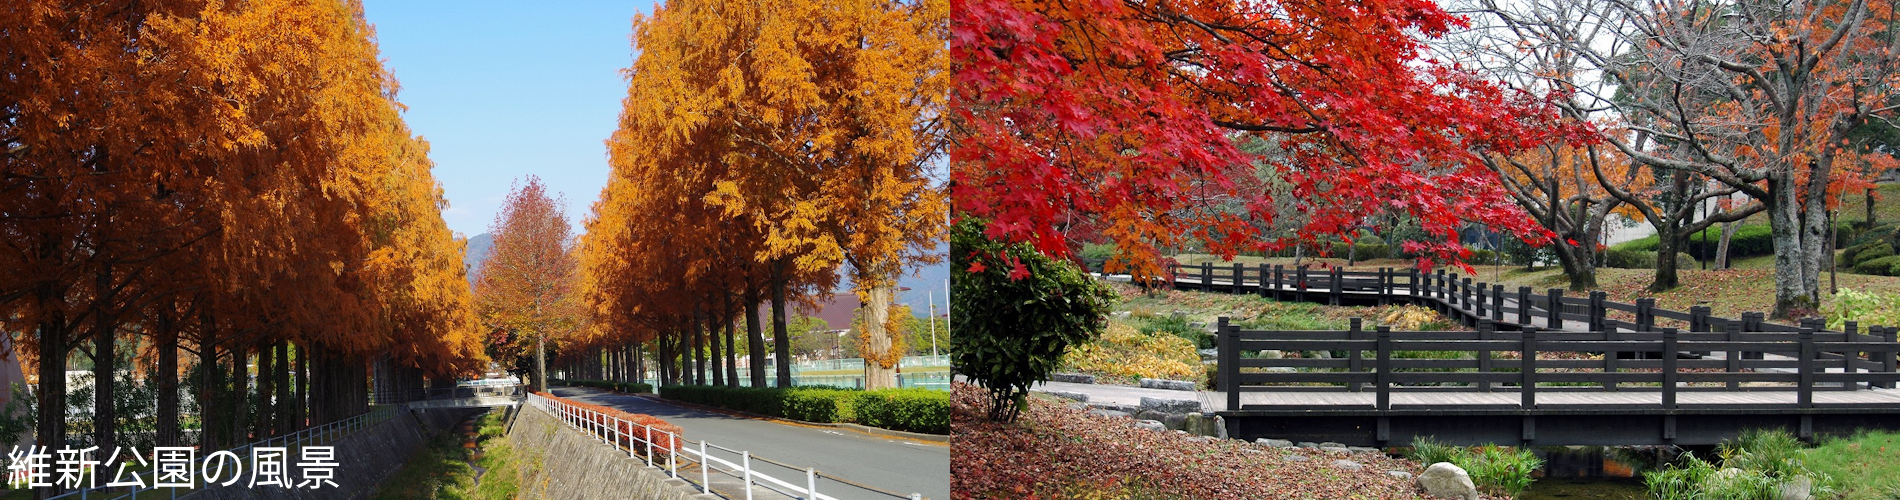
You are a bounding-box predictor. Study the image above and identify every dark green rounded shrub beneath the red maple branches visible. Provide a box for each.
[950,217,1115,422]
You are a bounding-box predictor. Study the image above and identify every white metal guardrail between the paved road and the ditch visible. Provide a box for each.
[528,394,923,500]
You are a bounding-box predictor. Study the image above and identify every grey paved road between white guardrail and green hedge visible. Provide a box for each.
[553,388,950,500]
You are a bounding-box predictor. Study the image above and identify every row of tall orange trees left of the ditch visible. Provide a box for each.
[0,0,486,475]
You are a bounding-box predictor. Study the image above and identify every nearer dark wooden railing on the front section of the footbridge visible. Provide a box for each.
[1218,317,1900,411]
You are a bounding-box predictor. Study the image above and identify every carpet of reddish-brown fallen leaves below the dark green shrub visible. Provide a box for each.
[950,382,1423,500]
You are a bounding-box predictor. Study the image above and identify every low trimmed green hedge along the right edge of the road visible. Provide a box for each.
[659,386,950,433]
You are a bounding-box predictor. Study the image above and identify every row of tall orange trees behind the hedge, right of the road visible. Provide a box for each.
[566,0,950,388]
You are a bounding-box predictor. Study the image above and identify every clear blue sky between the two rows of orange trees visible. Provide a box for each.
[363,0,654,236]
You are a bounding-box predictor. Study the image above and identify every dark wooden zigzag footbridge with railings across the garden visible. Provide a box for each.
[1117,264,1900,445]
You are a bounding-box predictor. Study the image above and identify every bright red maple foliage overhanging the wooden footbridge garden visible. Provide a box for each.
[950,0,1575,276]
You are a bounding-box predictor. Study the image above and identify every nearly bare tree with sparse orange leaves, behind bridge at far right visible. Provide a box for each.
[1474,0,1900,317]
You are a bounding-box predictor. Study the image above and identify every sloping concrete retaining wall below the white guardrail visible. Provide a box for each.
[507,405,718,500]
